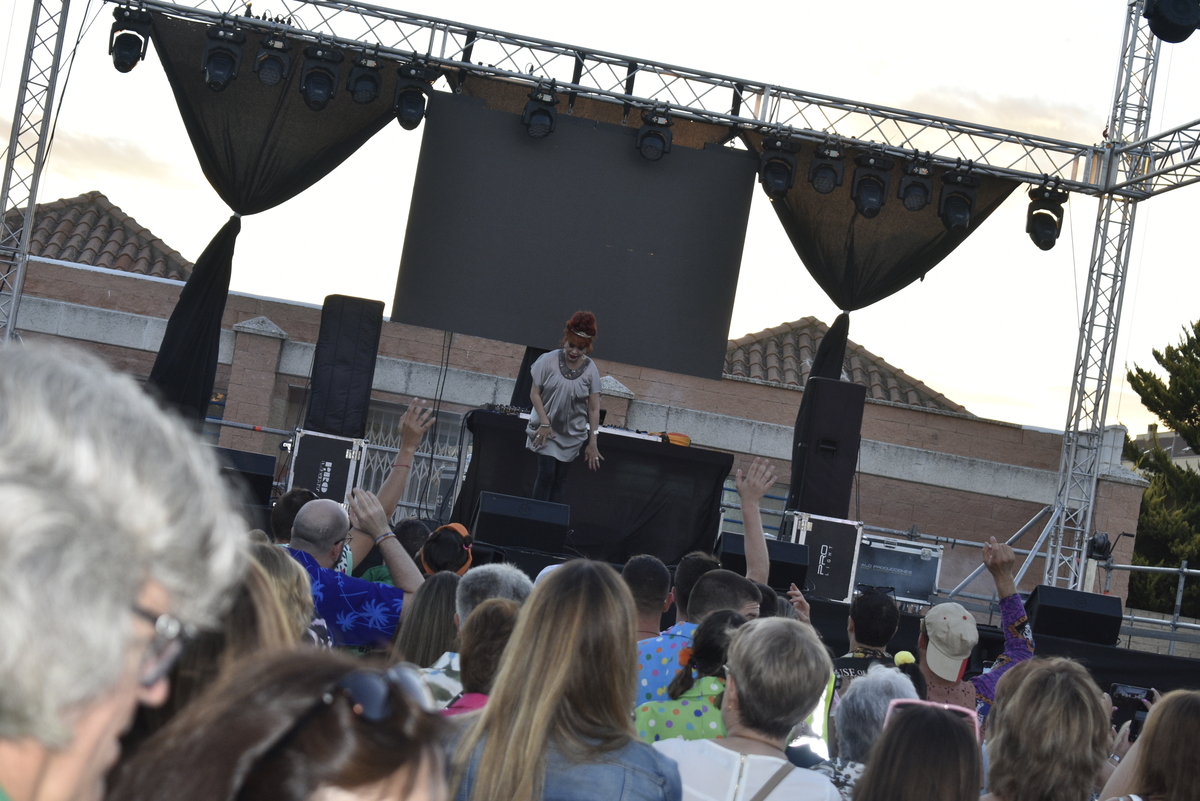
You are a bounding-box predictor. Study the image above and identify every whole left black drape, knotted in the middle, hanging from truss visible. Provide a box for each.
[150,14,398,421]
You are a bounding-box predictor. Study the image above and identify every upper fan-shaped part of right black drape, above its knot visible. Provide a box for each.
[754,136,1018,312]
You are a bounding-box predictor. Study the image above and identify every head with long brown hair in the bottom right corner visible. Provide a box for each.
[1100,689,1200,801]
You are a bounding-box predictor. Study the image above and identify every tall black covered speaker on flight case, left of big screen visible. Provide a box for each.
[304,295,383,439]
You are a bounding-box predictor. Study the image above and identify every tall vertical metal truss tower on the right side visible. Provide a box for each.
[1043,0,1162,590]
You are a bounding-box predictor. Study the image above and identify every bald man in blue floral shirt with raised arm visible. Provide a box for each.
[289,489,425,646]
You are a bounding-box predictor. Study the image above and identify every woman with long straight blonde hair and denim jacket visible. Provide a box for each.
[452,559,680,801]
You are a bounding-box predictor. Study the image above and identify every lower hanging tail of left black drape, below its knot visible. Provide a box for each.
[150,217,241,421]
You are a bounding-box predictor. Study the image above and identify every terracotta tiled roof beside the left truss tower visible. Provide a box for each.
[6,192,192,281]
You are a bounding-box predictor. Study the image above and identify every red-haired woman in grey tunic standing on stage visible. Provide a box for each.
[526,312,604,504]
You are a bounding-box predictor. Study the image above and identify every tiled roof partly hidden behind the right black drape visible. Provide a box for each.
[725,317,970,414]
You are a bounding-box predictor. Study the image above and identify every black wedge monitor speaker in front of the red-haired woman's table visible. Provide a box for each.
[470,492,571,554]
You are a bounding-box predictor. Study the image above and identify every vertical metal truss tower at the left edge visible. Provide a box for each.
[0,0,71,343]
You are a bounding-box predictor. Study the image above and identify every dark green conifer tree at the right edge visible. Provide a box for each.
[1126,321,1200,618]
